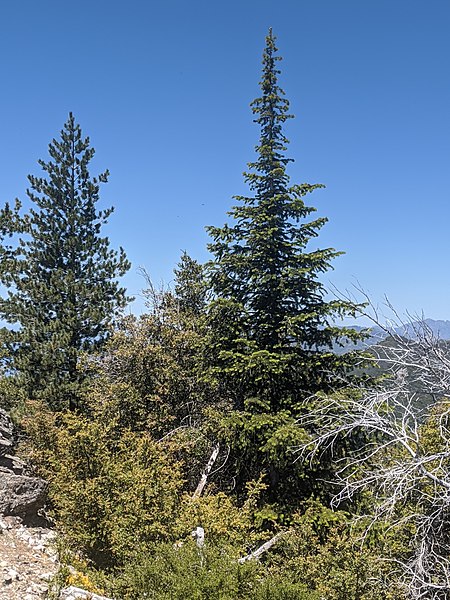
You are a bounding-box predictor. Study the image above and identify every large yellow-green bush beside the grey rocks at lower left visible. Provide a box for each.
[22,404,183,567]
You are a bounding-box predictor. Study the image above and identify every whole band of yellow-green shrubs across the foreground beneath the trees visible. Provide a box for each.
[20,400,408,600]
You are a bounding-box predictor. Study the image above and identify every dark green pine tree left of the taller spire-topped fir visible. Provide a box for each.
[0,114,130,409]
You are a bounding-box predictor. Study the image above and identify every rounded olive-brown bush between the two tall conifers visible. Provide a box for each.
[91,310,214,436]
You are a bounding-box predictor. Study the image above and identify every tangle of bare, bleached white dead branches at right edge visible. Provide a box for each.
[298,302,450,600]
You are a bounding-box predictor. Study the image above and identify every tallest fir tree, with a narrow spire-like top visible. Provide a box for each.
[208,30,361,504]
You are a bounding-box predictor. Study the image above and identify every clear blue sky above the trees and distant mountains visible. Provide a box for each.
[0,0,450,319]
